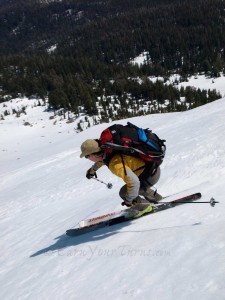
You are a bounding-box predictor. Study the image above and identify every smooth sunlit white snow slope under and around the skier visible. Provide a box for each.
[0,98,225,300]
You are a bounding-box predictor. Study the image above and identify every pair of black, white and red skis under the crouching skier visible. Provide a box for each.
[66,193,202,236]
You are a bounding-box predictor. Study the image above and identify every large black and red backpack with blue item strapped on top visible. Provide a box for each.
[100,122,166,167]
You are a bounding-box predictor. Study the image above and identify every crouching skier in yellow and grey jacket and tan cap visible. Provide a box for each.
[80,139,162,217]
